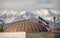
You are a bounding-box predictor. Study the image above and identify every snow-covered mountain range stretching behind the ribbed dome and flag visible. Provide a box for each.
[0,9,60,28]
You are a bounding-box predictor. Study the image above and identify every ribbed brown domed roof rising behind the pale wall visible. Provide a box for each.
[4,20,42,32]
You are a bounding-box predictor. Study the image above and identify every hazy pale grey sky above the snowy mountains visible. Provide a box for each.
[0,0,60,10]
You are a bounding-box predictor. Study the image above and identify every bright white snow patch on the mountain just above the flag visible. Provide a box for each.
[33,9,52,21]
